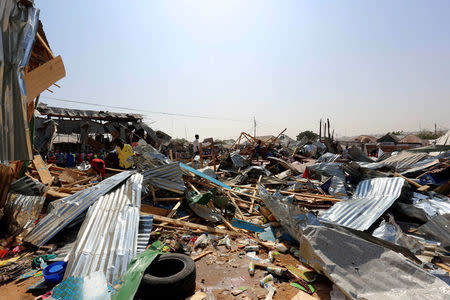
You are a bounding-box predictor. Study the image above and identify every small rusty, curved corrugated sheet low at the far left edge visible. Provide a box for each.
[4,193,45,235]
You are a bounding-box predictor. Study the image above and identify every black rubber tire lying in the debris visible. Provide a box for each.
[135,253,196,299]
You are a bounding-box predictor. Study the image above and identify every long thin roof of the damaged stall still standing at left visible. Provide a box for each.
[37,103,143,122]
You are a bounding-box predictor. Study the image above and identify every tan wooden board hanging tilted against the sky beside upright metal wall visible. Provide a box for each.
[23,56,66,102]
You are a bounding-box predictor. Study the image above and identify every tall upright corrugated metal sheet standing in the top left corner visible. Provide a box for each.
[0,0,39,161]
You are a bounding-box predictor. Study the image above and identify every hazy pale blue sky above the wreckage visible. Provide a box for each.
[35,0,450,139]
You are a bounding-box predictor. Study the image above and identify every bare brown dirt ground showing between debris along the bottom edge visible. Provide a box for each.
[0,246,331,300]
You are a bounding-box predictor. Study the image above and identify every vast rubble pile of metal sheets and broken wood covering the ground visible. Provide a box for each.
[0,130,450,299]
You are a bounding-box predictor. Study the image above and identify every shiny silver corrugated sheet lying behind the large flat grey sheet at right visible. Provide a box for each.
[320,177,405,230]
